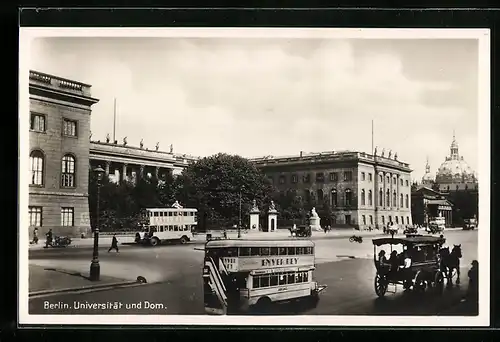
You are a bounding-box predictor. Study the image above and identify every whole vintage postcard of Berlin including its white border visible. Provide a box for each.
[19,28,490,326]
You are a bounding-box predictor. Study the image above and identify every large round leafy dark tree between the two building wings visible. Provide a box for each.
[175,153,273,227]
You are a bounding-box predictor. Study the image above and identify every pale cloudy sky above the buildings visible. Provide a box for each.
[30,37,478,180]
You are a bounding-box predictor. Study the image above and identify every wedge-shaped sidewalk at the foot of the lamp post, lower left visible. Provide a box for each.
[29,265,136,295]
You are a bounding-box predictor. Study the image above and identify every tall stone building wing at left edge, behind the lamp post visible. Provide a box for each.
[29,71,98,239]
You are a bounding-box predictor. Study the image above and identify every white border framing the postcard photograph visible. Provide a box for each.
[18,28,491,327]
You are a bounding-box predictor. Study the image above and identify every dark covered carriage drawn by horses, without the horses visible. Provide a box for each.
[373,235,445,297]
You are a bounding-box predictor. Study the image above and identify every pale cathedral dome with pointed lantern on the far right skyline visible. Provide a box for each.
[436,133,476,183]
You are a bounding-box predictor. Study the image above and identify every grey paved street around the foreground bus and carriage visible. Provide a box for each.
[29,230,477,315]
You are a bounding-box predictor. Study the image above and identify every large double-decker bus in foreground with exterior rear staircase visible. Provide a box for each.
[203,240,326,314]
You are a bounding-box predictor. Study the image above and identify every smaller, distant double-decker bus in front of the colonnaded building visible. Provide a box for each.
[135,207,198,246]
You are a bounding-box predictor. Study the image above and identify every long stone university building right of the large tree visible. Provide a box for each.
[252,150,412,229]
